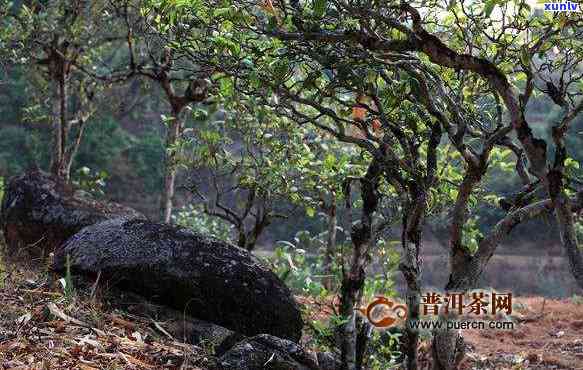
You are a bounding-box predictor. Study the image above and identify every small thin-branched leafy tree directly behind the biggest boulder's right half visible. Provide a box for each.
[184,104,292,251]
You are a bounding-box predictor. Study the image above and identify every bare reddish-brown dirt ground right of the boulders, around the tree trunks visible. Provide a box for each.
[300,297,583,370]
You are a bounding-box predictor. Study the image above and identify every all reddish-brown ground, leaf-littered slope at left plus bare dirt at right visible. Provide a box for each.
[0,264,583,370]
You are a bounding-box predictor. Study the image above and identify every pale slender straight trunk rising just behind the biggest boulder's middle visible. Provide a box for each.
[160,108,183,223]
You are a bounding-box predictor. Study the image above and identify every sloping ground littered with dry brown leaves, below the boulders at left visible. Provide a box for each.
[0,268,217,370]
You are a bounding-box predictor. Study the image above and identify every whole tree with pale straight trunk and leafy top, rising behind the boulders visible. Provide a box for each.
[109,0,210,223]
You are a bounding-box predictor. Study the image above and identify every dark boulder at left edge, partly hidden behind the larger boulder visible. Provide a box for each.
[0,170,145,257]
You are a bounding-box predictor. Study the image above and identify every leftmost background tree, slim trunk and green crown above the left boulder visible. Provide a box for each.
[0,0,124,182]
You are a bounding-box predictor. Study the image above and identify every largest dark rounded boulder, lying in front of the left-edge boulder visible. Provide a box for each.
[54,219,303,341]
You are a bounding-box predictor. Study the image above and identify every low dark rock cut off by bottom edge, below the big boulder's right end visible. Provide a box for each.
[219,334,320,370]
